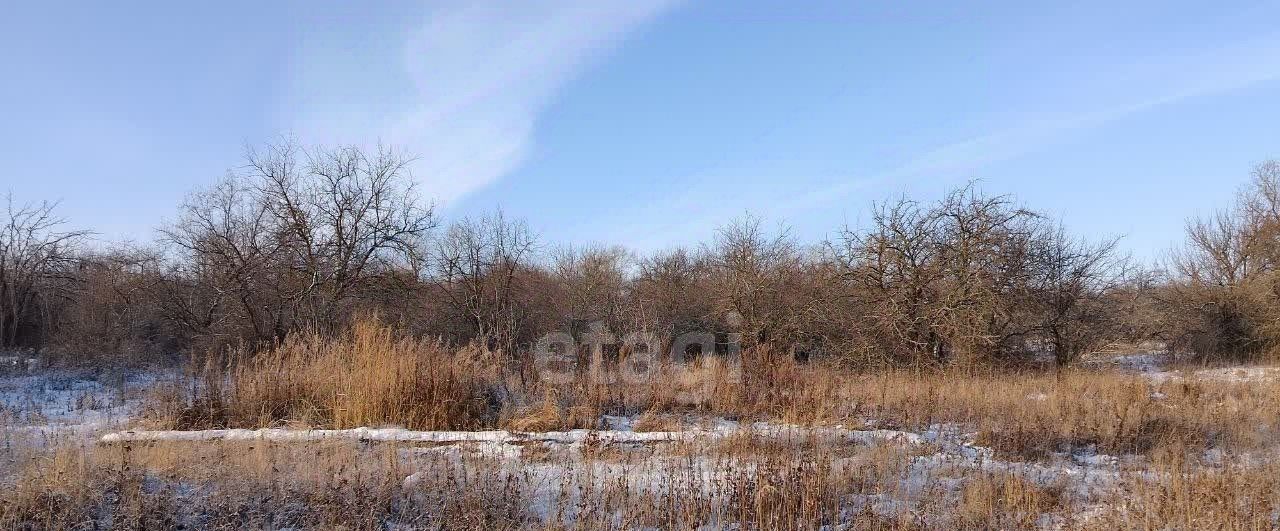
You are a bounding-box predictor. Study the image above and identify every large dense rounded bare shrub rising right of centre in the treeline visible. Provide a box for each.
[832,184,1120,367]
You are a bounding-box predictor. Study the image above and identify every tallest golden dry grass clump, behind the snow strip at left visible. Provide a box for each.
[174,321,499,430]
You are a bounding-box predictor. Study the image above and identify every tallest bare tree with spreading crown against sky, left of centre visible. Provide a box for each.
[248,145,435,326]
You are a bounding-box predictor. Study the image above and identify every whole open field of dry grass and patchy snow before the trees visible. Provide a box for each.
[0,337,1280,530]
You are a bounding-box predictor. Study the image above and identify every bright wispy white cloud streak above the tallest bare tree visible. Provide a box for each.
[379,0,676,201]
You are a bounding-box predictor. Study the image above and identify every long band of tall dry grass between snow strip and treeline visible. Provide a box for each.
[154,321,1280,459]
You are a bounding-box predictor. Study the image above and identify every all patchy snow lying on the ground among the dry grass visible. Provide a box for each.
[0,352,1280,528]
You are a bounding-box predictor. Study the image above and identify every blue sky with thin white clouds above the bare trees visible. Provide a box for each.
[0,0,1280,263]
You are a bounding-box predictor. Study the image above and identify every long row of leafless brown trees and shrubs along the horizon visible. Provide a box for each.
[0,143,1280,366]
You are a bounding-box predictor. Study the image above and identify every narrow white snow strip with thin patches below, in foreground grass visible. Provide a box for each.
[100,417,1121,527]
